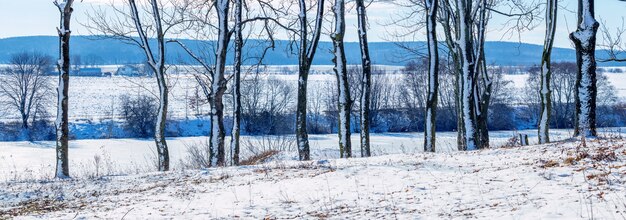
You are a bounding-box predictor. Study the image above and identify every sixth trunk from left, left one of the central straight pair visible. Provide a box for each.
[331,0,352,158]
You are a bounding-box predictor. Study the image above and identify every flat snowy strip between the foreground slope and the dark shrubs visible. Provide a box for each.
[0,128,626,182]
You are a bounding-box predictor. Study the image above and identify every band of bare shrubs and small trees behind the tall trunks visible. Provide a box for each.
[0,53,626,140]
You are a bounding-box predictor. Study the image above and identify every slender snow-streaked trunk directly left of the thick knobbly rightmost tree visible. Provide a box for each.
[538,0,558,144]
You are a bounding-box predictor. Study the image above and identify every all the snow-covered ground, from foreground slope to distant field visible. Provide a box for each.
[0,65,626,219]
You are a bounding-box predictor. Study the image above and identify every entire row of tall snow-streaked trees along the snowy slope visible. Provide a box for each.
[39,0,620,177]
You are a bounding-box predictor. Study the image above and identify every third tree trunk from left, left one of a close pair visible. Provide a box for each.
[209,0,230,166]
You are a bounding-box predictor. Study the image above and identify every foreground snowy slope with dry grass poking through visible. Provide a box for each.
[0,138,626,219]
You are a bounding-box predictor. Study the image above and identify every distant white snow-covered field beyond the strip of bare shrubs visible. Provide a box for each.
[0,69,626,120]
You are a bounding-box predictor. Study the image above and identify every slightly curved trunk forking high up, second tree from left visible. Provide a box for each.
[128,0,170,171]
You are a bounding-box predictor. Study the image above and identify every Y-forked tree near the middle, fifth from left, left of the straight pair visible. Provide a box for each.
[296,0,325,160]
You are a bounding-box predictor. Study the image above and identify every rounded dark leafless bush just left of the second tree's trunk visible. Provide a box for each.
[121,95,158,138]
